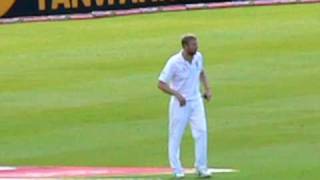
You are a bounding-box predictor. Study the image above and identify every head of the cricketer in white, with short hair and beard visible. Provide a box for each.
[181,34,198,56]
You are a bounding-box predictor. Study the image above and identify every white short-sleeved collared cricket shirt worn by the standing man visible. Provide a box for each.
[159,50,204,101]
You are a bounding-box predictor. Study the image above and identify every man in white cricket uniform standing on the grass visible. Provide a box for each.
[158,34,212,178]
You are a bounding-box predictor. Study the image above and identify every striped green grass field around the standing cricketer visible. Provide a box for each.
[0,4,320,180]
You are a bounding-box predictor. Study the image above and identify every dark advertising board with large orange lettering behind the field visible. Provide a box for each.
[0,0,227,18]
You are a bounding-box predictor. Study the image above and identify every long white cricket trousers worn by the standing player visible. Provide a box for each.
[168,97,208,173]
